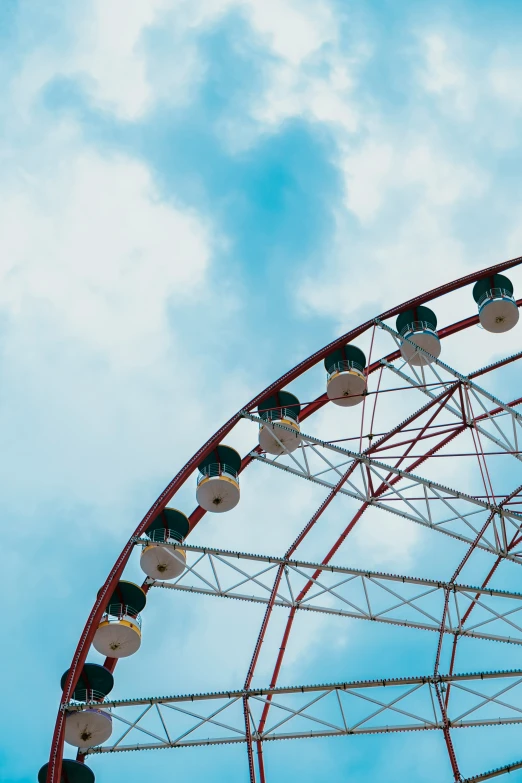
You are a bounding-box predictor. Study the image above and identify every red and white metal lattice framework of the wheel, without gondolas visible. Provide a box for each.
[47,258,522,783]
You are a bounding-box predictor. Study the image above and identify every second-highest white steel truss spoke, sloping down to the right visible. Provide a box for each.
[242,411,522,563]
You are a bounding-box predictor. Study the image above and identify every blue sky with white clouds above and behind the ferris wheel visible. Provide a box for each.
[0,0,522,783]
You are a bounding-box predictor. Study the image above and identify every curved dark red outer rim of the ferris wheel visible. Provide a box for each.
[47,256,522,783]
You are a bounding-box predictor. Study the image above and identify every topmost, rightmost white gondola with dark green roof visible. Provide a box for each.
[473,275,519,334]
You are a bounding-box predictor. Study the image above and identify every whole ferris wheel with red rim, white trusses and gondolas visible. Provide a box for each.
[38,258,522,783]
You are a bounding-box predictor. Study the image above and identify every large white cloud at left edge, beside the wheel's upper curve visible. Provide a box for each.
[0,115,225,521]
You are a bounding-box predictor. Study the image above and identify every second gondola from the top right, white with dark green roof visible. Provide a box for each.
[397,307,441,367]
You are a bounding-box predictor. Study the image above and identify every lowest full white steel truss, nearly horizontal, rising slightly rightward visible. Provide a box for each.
[74,670,522,754]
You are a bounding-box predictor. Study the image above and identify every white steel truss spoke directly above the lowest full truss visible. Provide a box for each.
[140,539,522,644]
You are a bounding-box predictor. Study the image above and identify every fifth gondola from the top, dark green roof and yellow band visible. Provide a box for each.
[196,446,241,514]
